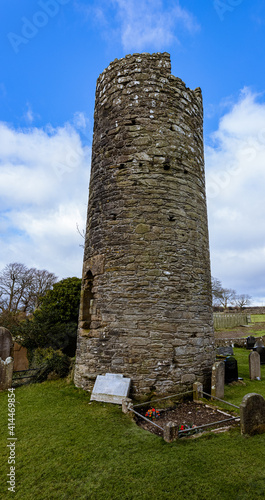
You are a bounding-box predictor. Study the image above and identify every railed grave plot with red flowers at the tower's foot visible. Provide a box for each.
[133,400,240,438]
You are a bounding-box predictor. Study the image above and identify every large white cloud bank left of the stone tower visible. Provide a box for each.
[0,123,90,278]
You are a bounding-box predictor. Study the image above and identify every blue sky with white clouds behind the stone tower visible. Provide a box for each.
[0,0,265,304]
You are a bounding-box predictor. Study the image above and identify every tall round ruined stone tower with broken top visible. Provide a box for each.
[75,53,215,396]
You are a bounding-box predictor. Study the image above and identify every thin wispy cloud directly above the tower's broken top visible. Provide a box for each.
[76,0,200,52]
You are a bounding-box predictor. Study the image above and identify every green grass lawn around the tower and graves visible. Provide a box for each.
[0,349,265,500]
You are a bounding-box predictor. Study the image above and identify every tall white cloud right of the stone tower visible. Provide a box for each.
[205,89,265,304]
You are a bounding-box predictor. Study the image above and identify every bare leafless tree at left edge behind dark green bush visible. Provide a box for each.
[0,262,57,313]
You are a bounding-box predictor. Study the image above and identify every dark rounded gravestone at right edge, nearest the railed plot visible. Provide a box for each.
[240,393,265,435]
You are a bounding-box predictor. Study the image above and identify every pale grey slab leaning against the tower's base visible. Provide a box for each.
[90,373,131,404]
